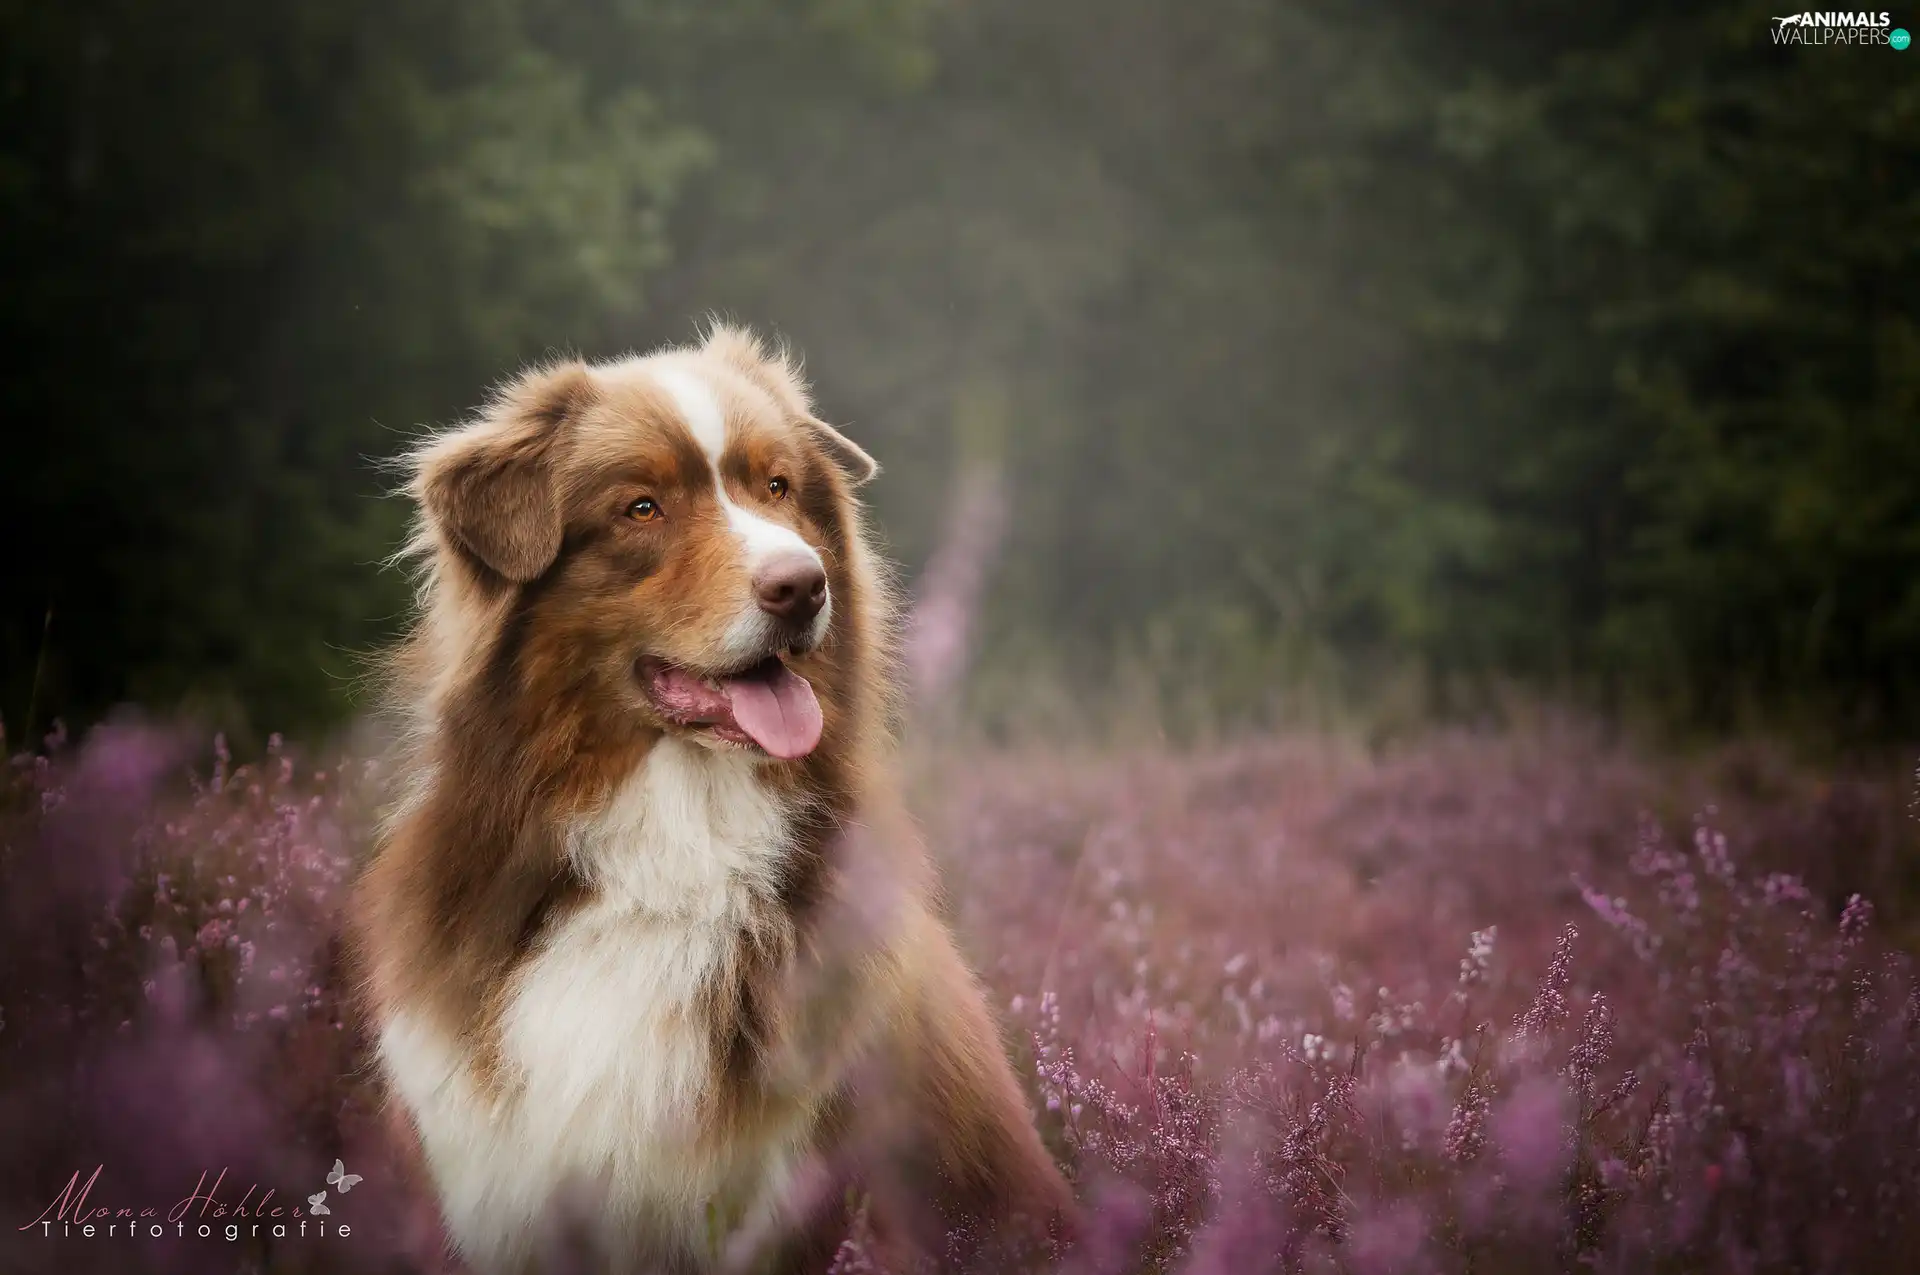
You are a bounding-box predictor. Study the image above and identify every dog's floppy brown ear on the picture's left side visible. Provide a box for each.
[413,361,595,584]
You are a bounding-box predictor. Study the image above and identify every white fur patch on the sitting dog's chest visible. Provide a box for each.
[380,739,799,1269]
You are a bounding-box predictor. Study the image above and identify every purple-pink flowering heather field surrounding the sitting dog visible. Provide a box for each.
[0,702,1920,1275]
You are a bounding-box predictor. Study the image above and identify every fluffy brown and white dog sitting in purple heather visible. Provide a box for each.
[355,326,1071,1271]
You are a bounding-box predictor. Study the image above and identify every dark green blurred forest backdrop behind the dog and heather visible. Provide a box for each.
[0,0,1920,747]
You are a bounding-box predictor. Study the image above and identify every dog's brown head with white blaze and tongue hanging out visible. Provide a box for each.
[413,328,877,758]
